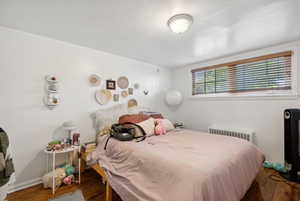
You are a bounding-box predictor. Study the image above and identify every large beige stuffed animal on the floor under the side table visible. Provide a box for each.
[43,168,66,188]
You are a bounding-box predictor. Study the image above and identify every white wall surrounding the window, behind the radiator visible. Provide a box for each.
[172,42,300,162]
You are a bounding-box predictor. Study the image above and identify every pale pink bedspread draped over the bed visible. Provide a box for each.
[89,130,264,201]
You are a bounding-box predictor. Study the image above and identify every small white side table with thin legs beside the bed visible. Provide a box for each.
[44,146,81,194]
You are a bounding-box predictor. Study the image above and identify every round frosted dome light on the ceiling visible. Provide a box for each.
[167,13,193,33]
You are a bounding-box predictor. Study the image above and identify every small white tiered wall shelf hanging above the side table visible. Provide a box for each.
[43,75,60,110]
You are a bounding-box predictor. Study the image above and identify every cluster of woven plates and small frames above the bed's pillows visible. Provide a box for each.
[89,74,140,107]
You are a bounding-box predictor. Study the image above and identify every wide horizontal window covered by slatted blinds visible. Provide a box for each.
[192,51,292,95]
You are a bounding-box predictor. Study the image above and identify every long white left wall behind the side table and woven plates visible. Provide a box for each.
[0,27,170,189]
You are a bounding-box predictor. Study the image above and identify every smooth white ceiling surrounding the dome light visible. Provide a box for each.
[0,0,300,67]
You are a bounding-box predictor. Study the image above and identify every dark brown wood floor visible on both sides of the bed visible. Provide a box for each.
[8,169,300,201]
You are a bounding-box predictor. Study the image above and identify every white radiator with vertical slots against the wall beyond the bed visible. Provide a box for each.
[208,126,254,143]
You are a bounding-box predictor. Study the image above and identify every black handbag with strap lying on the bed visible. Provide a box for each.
[104,122,146,150]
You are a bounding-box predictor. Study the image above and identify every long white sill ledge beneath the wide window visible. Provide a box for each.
[189,94,300,101]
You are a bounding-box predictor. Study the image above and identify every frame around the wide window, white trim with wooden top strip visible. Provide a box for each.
[190,48,299,99]
